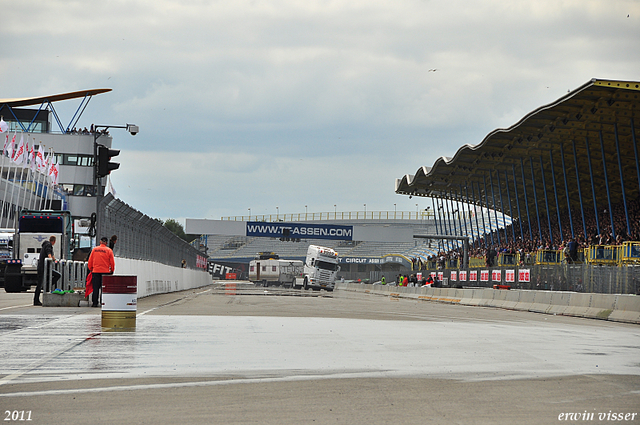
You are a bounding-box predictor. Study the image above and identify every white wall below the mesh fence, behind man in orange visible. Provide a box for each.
[115,257,212,298]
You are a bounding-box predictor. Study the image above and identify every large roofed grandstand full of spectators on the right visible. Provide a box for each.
[396,79,640,293]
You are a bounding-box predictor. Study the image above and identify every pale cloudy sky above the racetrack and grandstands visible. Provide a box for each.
[0,0,640,224]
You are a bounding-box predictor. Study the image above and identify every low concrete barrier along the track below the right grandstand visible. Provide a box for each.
[336,283,640,324]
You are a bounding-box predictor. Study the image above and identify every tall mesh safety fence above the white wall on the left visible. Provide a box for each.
[97,194,206,269]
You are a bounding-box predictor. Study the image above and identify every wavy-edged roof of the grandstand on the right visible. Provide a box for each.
[396,79,640,215]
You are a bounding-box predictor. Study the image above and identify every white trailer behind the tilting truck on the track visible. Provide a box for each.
[249,252,303,288]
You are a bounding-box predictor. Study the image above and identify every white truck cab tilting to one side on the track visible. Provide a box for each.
[294,245,340,291]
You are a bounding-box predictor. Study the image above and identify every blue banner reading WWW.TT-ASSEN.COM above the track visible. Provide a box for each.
[247,221,353,241]
